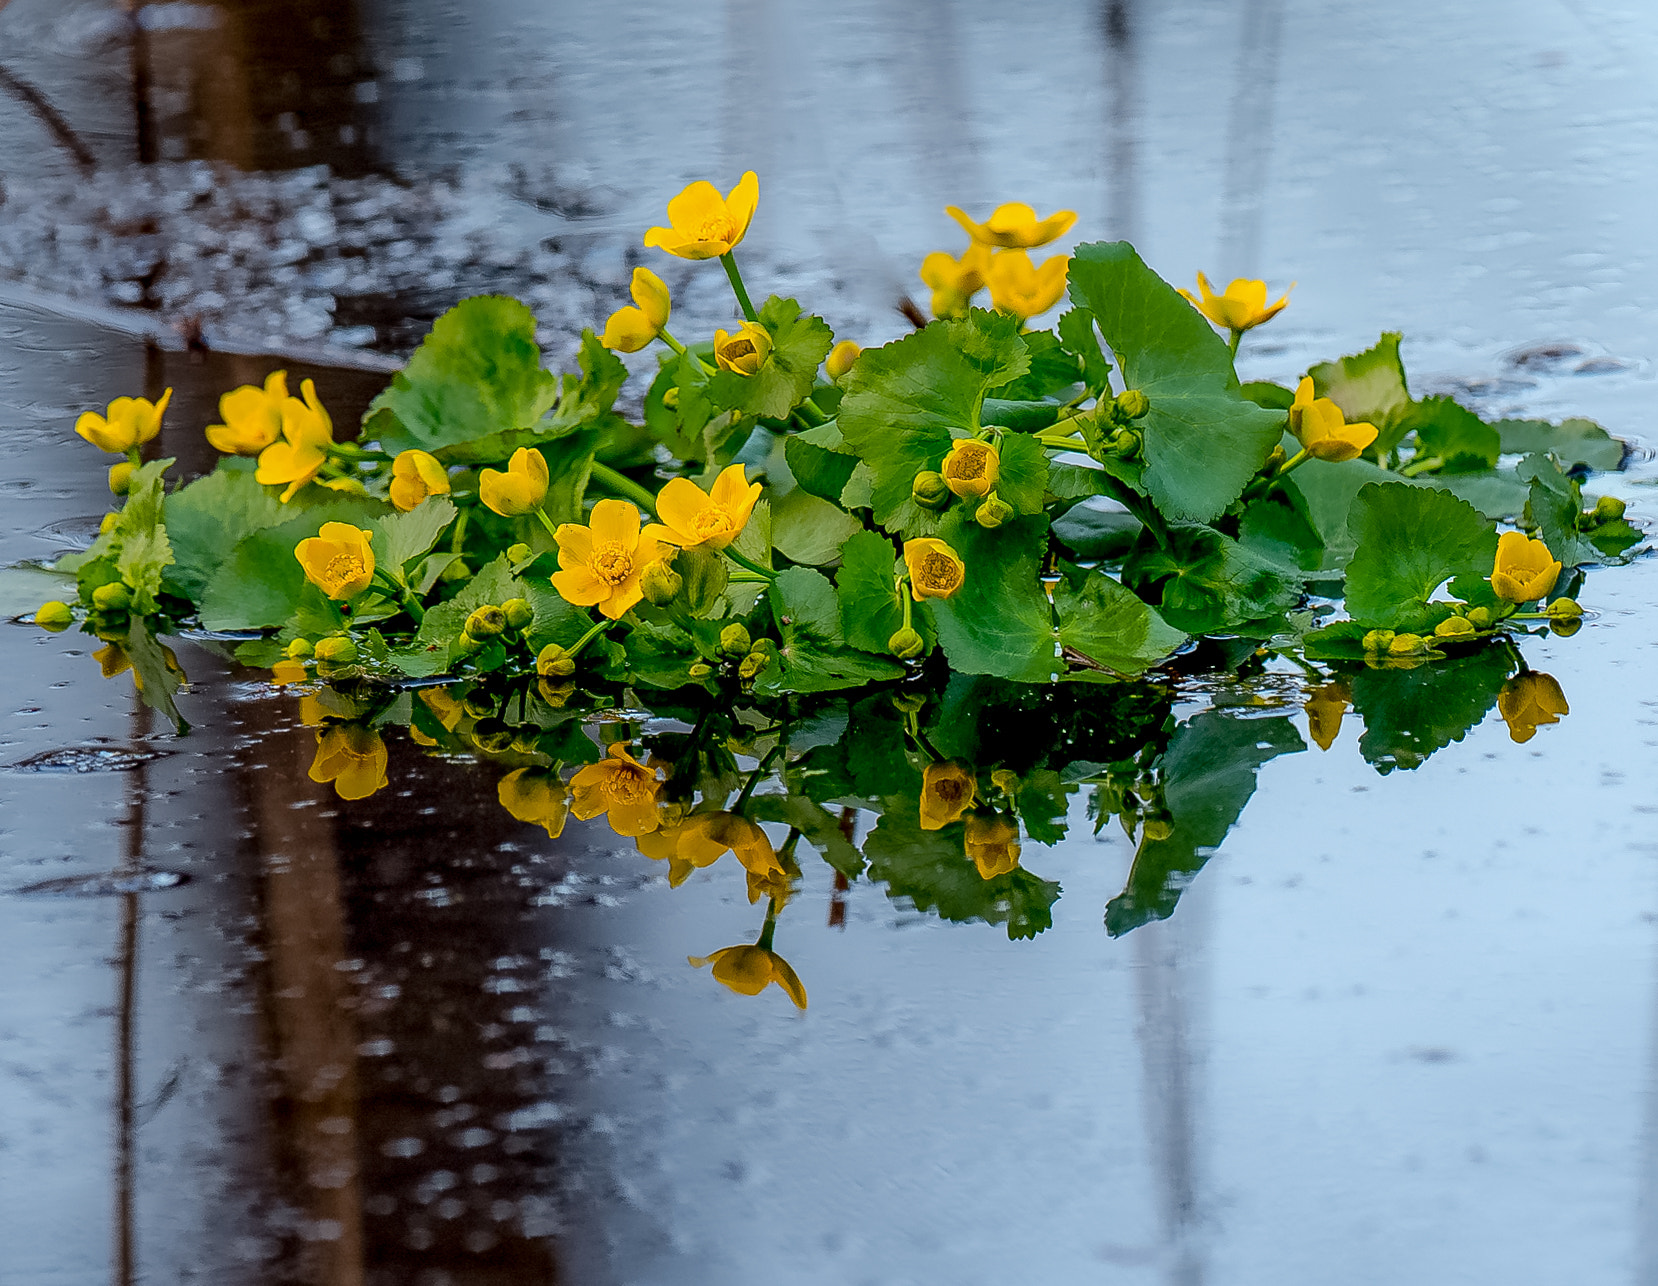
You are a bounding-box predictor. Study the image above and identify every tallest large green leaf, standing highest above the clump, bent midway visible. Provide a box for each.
[1071,242,1283,522]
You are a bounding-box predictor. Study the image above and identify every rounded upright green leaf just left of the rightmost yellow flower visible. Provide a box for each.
[1346,482,1497,630]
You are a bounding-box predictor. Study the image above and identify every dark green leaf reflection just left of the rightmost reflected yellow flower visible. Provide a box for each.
[1353,646,1510,776]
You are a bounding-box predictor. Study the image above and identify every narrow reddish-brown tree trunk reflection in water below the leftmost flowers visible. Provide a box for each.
[249,706,363,1286]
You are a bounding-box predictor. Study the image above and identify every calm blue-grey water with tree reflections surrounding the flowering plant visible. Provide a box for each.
[0,0,1658,1286]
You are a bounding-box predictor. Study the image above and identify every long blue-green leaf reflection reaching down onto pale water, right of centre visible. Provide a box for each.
[1106,709,1307,938]
